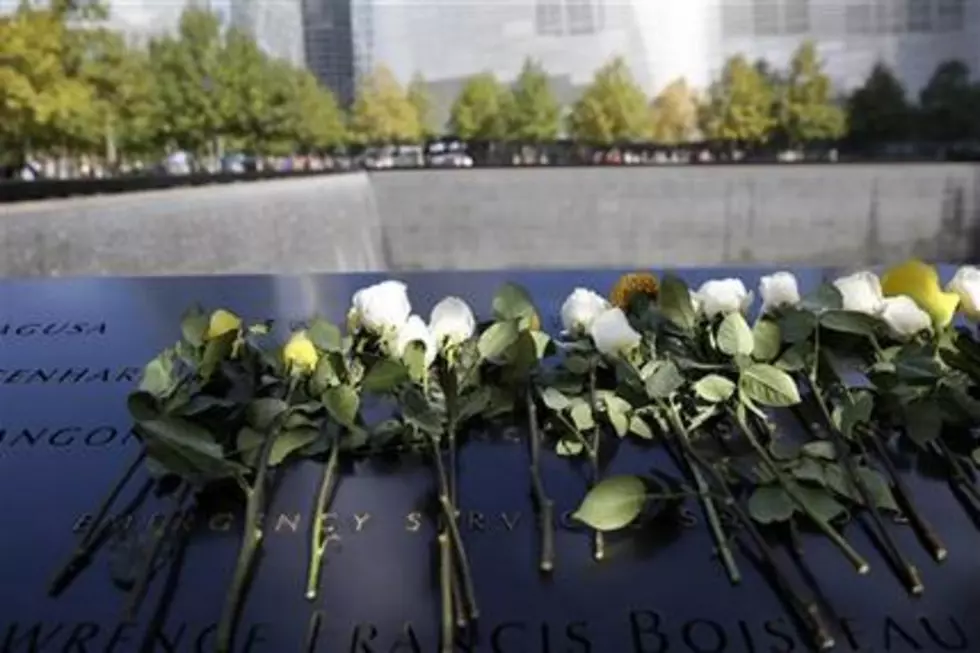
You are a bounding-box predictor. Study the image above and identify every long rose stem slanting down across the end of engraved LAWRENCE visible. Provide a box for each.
[215,402,292,653]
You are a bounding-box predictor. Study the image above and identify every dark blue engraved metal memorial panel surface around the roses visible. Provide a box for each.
[0,270,980,653]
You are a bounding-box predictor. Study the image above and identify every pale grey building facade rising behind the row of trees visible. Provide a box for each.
[350,0,980,129]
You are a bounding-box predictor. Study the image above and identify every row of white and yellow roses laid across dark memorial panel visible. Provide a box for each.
[47,260,980,653]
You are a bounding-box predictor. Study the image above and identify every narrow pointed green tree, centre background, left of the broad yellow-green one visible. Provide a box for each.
[506,59,561,143]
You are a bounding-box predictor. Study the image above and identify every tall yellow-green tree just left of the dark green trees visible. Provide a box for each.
[778,41,847,146]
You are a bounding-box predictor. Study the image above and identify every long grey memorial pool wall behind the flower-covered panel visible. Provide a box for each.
[0,164,980,276]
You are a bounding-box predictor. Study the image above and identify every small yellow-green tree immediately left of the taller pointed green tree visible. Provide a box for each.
[449,73,510,141]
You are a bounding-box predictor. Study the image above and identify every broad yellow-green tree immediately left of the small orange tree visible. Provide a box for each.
[568,57,649,144]
